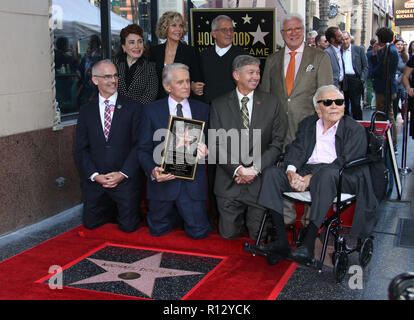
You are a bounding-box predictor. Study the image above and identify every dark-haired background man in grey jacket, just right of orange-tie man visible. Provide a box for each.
[325,27,344,90]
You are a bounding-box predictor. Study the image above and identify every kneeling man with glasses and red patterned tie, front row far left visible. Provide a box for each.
[76,60,142,232]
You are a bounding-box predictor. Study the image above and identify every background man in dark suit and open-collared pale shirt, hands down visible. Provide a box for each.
[342,31,368,120]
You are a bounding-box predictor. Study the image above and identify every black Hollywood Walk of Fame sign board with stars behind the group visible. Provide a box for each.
[191,8,276,59]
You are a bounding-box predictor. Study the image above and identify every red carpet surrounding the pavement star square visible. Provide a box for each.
[0,224,297,300]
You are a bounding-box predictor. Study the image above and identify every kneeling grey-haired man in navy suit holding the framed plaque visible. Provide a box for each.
[138,63,210,239]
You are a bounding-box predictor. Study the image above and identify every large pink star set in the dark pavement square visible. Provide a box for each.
[70,253,202,298]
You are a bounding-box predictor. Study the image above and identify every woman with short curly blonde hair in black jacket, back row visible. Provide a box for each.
[150,11,203,99]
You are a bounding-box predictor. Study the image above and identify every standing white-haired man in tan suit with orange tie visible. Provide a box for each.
[260,14,332,224]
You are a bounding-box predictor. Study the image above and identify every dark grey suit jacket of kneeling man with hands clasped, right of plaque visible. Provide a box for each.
[209,90,286,201]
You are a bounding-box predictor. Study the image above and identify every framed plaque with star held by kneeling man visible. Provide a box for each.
[161,116,205,180]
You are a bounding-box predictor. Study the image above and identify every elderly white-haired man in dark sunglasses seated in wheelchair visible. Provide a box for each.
[258,85,377,263]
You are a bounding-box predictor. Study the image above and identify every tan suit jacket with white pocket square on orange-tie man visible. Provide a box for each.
[260,46,333,145]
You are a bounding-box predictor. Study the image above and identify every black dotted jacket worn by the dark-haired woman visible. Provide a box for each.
[113,54,158,104]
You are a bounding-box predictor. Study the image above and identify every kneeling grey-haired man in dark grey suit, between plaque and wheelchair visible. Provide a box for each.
[209,55,286,239]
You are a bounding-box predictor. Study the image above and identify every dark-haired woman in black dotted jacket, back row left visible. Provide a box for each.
[113,24,159,104]
